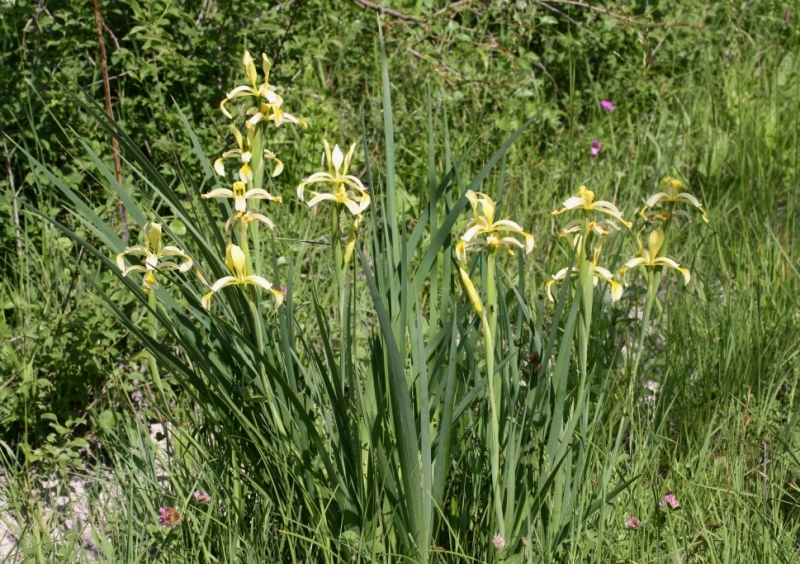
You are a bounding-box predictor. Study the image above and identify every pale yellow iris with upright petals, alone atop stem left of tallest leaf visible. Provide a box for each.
[297,141,369,215]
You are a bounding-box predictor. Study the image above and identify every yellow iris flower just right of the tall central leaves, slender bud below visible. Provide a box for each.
[456,190,534,263]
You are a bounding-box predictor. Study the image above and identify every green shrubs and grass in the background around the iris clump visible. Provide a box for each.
[0,0,800,562]
